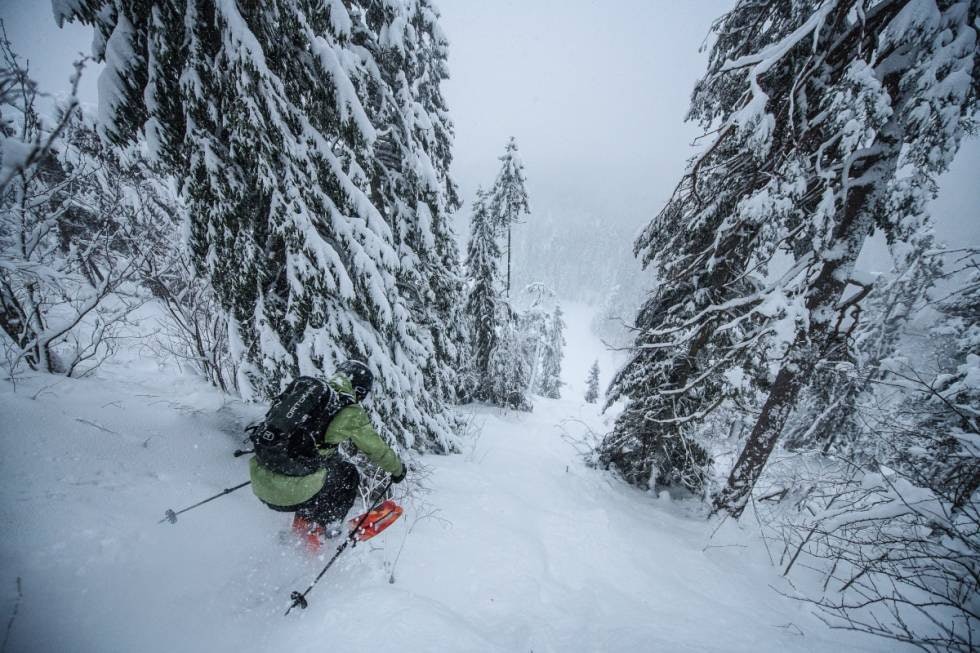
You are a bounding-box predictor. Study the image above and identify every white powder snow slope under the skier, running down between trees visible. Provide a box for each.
[0,306,895,653]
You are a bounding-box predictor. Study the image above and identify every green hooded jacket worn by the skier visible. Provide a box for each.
[255,374,404,507]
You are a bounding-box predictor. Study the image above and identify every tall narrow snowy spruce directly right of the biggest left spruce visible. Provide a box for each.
[362,0,468,403]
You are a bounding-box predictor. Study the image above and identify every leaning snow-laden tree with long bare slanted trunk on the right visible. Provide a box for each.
[701,0,980,517]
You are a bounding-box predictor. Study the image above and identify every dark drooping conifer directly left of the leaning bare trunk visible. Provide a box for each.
[594,18,776,494]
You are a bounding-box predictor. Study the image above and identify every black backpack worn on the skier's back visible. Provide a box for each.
[249,376,354,476]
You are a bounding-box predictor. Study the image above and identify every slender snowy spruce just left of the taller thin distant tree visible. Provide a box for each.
[466,189,502,401]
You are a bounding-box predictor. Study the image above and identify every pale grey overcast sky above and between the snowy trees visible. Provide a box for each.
[0,0,980,264]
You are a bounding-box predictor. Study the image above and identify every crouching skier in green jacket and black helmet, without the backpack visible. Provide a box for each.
[249,360,406,553]
